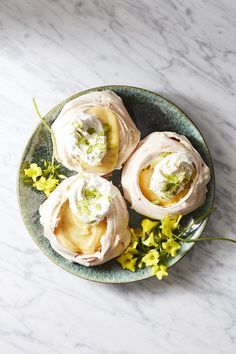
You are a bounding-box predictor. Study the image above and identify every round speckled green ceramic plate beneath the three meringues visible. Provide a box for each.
[17,86,214,283]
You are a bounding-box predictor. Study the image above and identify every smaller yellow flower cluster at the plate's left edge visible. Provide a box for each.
[24,160,66,197]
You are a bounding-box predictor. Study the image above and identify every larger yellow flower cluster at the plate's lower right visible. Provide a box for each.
[117,216,181,280]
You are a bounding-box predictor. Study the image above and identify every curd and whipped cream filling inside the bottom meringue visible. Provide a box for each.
[55,174,111,254]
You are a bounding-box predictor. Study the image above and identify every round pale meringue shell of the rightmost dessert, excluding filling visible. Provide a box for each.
[121,132,210,219]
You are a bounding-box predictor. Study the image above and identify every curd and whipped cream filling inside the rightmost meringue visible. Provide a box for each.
[139,152,196,206]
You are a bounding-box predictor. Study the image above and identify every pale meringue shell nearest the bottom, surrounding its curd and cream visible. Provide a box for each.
[39,174,131,266]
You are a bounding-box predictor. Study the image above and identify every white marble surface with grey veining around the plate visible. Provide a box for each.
[0,0,236,354]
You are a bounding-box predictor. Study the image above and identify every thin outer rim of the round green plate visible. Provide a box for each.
[16,85,215,284]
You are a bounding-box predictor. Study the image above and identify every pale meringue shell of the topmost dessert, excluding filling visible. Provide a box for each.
[51,91,140,175]
